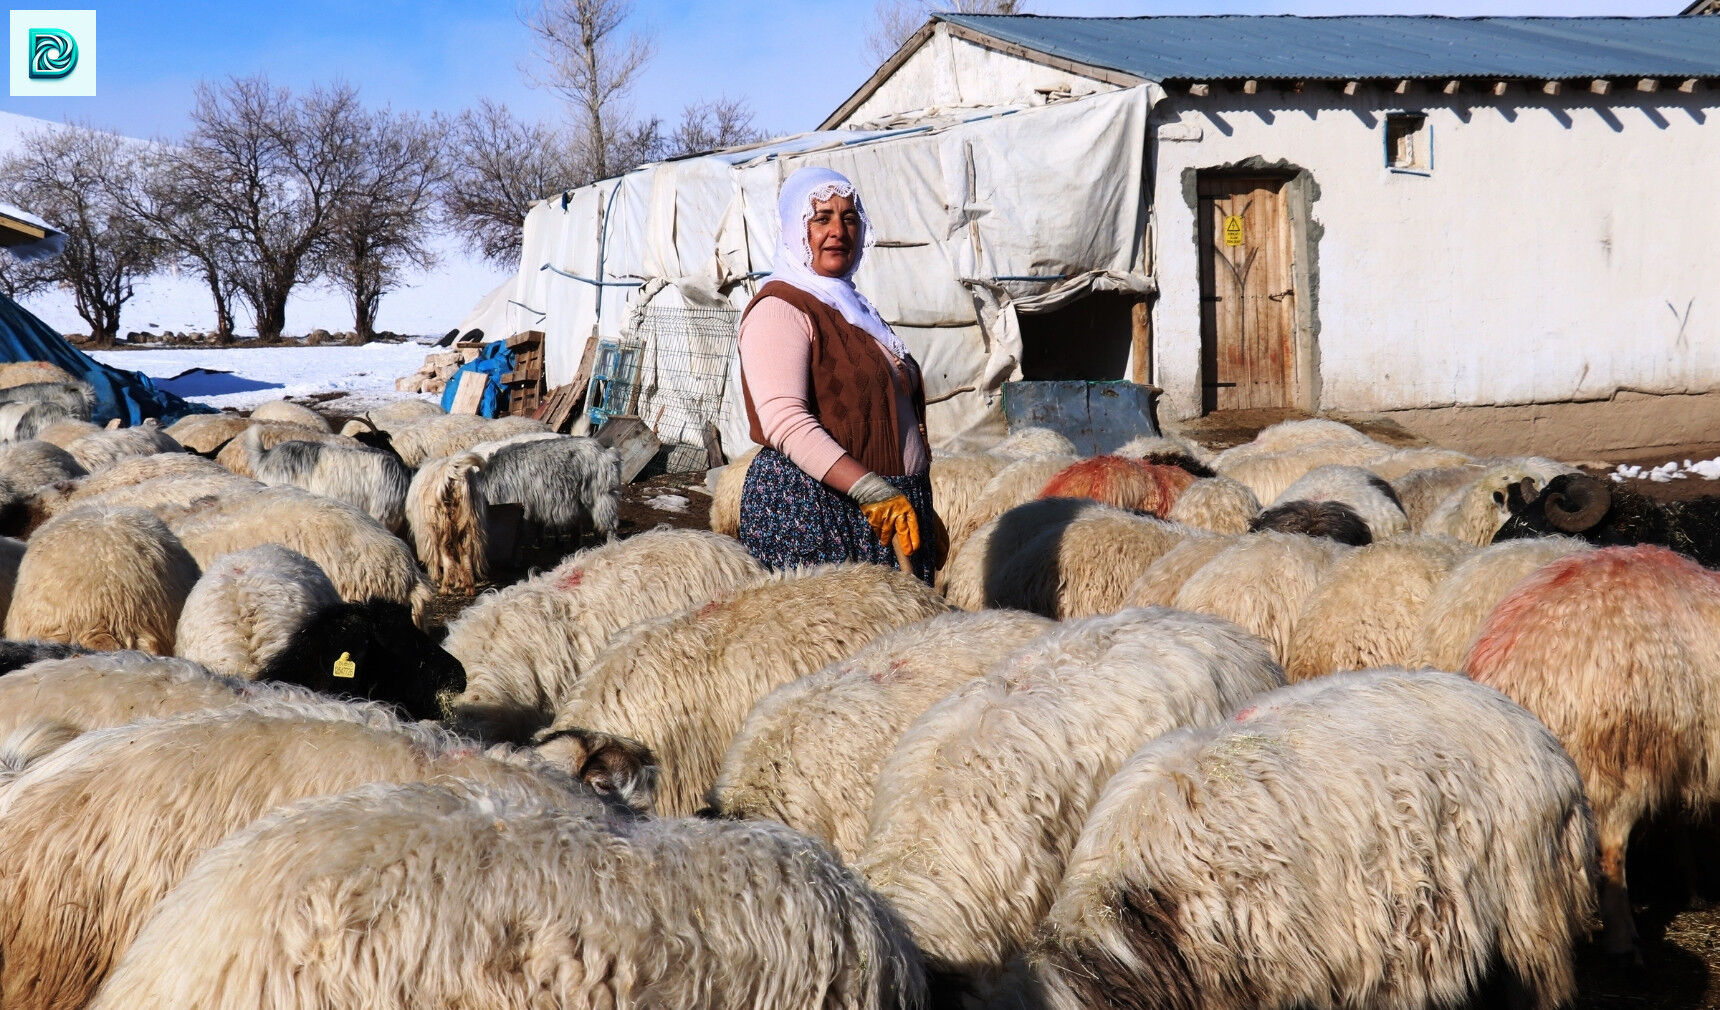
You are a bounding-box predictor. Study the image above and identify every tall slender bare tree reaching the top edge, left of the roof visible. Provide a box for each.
[523,0,652,182]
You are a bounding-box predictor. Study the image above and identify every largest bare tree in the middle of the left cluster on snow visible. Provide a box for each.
[177,77,365,339]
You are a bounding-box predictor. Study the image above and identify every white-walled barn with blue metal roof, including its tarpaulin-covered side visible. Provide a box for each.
[490,14,1720,458]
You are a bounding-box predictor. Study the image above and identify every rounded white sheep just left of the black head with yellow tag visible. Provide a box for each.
[174,544,341,680]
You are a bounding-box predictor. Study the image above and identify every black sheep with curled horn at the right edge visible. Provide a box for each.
[1493,473,1720,568]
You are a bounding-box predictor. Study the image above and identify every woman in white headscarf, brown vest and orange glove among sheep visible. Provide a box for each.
[740,169,936,582]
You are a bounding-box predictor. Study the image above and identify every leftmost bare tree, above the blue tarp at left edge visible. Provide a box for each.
[0,126,163,344]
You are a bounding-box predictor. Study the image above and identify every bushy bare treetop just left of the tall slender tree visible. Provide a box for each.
[442,100,585,265]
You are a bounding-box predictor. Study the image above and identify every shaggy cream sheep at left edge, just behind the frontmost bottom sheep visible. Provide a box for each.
[0,699,626,1010]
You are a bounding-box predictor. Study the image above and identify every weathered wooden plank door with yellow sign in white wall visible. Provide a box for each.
[1195,174,1297,411]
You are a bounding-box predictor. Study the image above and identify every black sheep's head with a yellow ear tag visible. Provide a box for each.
[258,599,466,719]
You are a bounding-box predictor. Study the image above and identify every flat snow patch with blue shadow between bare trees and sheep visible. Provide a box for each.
[89,341,433,413]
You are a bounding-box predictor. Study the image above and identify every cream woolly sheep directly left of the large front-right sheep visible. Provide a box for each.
[855,607,1283,989]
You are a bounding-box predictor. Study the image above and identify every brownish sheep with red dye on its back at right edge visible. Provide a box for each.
[1464,547,1720,953]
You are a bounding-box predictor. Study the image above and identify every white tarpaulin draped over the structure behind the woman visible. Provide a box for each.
[505,86,1158,454]
